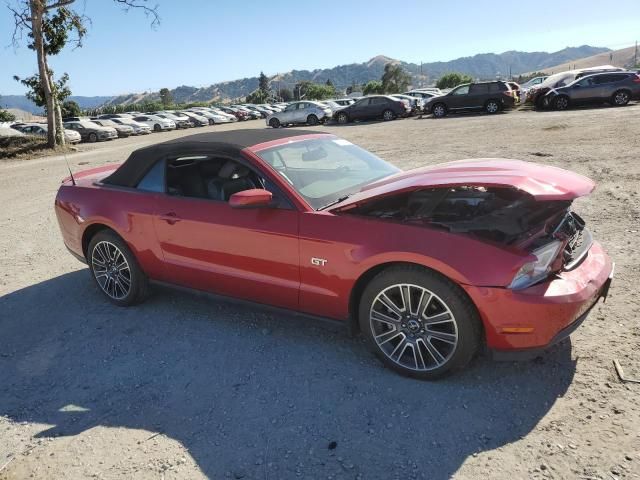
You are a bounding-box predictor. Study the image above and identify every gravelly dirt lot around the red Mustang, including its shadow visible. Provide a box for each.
[0,105,640,480]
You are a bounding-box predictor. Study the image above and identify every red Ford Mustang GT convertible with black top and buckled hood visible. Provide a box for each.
[55,129,613,379]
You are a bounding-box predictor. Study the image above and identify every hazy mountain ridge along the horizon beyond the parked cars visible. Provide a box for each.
[0,45,609,109]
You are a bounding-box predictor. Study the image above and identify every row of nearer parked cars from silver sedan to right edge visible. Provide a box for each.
[266,65,640,128]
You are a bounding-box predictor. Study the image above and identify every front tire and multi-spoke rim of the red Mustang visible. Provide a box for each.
[358,265,481,380]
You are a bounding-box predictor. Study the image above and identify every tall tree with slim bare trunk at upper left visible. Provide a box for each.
[7,0,159,148]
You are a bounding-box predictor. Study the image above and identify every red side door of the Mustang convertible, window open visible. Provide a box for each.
[154,155,300,309]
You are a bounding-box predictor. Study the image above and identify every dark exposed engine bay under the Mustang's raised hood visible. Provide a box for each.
[349,186,584,244]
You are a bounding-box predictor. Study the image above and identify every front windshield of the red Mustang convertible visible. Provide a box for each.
[252,137,400,210]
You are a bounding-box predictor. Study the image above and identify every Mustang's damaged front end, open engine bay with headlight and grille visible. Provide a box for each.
[336,185,592,290]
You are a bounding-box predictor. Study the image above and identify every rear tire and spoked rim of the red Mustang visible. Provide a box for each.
[87,230,149,307]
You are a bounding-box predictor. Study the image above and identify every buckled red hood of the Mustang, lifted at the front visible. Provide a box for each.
[331,158,595,210]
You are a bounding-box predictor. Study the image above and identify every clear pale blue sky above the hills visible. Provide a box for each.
[0,0,640,95]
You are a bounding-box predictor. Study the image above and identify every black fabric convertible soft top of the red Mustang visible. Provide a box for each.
[102,128,327,187]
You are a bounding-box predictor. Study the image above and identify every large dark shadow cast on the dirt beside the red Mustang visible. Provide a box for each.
[0,269,575,479]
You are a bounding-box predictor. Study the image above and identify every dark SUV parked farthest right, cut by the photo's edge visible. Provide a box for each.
[543,72,640,110]
